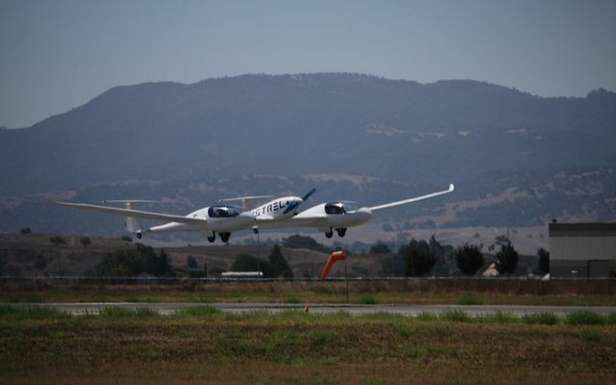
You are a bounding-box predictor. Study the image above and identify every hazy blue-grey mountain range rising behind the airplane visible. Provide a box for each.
[0,74,616,231]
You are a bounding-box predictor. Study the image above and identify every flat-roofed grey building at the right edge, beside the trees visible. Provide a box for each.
[549,223,616,278]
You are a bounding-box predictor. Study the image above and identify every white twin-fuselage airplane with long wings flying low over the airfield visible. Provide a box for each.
[57,184,454,243]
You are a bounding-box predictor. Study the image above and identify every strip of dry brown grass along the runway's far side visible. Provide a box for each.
[0,280,616,306]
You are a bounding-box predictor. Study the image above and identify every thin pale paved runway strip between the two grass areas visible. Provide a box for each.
[9,302,616,317]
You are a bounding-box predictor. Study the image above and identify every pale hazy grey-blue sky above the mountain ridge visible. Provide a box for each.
[0,0,616,127]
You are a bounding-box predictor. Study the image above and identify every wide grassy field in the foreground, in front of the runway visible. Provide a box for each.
[0,306,616,384]
